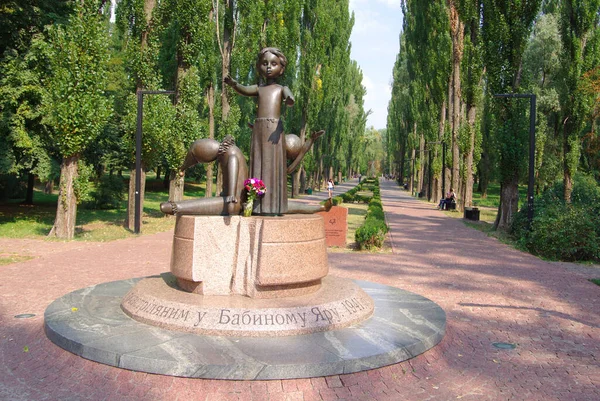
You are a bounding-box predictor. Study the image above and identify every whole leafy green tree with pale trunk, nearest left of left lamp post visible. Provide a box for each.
[44,0,111,239]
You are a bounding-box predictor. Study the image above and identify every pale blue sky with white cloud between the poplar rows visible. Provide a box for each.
[350,0,402,129]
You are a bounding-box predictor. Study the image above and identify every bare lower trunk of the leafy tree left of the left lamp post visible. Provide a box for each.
[48,155,79,239]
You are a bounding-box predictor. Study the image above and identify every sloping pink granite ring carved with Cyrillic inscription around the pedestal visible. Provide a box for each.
[121,273,373,337]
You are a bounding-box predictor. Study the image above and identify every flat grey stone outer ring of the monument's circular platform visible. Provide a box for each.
[44,276,446,380]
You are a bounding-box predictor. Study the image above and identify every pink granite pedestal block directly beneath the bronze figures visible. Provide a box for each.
[171,214,329,298]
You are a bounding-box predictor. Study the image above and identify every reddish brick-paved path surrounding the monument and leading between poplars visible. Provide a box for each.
[0,181,600,401]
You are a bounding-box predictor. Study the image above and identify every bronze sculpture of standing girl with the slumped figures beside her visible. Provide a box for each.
[160,47,331,215]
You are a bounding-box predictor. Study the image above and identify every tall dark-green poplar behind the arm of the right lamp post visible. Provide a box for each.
[482,0,541,230]
